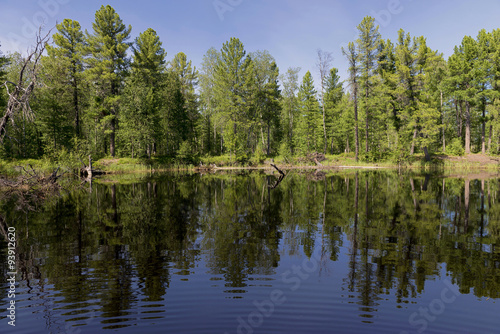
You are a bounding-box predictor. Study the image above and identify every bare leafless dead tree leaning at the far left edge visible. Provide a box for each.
[0,28,51,143]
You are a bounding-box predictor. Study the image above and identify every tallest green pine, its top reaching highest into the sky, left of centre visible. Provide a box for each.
[86,5,132,157]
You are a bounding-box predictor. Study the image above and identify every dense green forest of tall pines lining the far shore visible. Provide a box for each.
[0,5,500,163]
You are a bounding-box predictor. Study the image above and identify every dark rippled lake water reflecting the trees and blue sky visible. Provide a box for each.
[0,172,500,333]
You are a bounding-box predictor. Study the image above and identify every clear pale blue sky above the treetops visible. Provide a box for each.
[0,0,500,86]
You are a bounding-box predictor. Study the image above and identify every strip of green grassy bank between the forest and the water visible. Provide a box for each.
[0,154,500,176]
